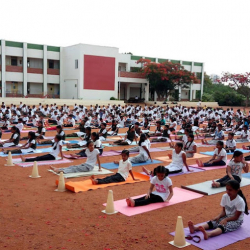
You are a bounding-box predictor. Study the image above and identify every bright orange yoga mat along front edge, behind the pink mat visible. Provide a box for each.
[56,172,149,193]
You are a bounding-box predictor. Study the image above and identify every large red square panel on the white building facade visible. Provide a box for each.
[83,55,115,90]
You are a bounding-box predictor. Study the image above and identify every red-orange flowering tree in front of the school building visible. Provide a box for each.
[137,58,198,97]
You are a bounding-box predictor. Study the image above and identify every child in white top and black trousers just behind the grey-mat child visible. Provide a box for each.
[196,141,227,168]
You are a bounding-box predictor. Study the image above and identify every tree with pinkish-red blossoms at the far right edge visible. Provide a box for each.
[218,72,250,106]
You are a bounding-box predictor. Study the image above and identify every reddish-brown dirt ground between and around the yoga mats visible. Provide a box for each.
[0,106,250,250]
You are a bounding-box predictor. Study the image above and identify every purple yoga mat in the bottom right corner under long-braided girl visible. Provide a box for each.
[170,212,250,250]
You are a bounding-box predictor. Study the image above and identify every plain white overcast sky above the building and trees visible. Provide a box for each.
[0,0,250,75]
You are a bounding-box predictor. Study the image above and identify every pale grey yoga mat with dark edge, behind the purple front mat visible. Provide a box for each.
[181,177,250,195]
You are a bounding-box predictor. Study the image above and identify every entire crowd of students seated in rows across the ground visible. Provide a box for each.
[0,101,250,239]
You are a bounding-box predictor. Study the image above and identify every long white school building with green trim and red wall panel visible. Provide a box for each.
[0,40,204,101]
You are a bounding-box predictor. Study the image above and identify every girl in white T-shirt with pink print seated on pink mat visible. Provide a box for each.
[126,166,174,207]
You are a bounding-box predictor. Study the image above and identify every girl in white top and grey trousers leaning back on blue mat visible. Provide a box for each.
[130,134,153,163]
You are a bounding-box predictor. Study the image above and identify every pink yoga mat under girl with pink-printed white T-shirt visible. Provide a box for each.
[103,187,203,216]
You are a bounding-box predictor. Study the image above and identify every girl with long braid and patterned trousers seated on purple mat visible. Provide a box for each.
[188,180,249,240]
